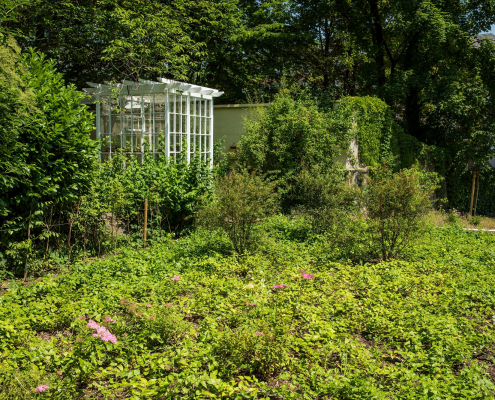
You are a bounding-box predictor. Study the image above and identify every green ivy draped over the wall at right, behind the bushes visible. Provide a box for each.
[336,97,495,216]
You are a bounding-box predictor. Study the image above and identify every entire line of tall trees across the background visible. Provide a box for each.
[2,0,495,160]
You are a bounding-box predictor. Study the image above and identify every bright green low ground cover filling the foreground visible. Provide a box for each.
[0,223,495,399]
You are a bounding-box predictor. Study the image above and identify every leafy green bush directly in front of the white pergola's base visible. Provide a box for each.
[100,154,212,239]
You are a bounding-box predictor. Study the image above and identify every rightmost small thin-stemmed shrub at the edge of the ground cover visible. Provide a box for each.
[363,169,437,260]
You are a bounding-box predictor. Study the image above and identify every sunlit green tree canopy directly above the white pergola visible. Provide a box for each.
[4,0,238,87]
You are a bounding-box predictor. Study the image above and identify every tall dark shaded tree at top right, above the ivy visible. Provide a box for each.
[292,0,495,164]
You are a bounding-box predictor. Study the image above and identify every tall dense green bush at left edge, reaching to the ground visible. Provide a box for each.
[0,44,97,276]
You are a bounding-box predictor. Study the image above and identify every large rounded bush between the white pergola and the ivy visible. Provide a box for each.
[238,88,350,210]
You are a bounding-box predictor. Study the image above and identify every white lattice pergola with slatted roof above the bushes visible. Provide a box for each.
[84,78,223,163]
